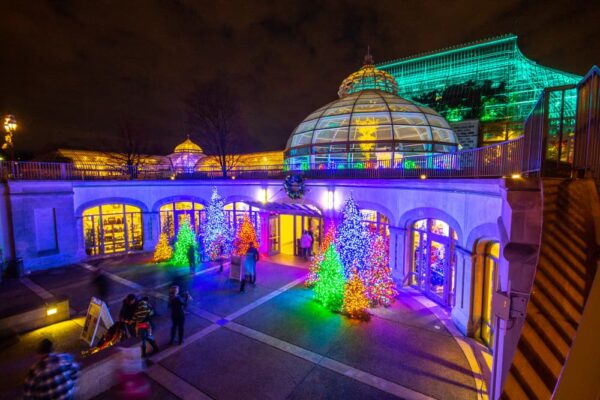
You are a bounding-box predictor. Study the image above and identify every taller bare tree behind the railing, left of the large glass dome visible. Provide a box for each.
[187,80,243,177]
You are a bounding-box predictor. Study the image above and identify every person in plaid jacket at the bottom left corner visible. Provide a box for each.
[23,339,79,400]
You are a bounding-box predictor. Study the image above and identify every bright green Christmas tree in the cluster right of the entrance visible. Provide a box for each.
[314,244,346,311]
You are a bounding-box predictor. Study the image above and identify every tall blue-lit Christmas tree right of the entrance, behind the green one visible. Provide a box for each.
[336,196,370,277]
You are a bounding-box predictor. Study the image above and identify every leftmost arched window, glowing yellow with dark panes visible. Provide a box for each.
[82,204,144,256]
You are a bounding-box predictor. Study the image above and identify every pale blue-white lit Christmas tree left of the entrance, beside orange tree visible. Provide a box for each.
[204,188,232,261]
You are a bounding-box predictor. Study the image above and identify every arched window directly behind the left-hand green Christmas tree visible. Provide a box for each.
[160,201,206,239]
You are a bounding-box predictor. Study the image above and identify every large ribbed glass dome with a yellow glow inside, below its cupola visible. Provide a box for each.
[285,87,458,169]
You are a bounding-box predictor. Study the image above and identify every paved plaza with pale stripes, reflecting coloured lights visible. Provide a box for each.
[0,254,486,399]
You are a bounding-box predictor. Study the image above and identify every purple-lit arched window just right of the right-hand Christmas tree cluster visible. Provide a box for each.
[410,219,458,306]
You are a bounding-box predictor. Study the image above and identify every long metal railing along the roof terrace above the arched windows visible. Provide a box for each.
[0,137,539,180]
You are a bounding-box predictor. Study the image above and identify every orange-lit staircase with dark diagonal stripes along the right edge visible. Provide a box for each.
[502,178,598,399]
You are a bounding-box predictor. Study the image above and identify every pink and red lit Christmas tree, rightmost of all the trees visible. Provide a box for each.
[362,235,398,307]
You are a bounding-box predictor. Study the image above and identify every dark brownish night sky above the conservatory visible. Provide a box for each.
[0,0,600,157]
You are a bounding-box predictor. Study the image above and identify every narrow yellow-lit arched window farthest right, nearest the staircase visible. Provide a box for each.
[481,242,500,348]
